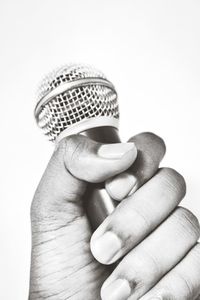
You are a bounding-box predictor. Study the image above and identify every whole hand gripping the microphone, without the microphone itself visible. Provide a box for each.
[30,134,200,300]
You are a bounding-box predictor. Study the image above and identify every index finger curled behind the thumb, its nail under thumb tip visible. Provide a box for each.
[106,132,166,201]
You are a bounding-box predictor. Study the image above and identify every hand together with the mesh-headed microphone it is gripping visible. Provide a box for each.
[29,66,200,300]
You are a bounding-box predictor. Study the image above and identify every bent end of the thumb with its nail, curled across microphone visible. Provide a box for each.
[64,135,137,183]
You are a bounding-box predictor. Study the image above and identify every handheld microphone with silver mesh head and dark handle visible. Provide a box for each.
[34,64,120,229]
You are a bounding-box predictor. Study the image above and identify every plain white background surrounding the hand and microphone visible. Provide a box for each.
[0,0,200,300]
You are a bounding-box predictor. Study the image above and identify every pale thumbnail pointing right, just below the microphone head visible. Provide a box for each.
[98,143,136,159]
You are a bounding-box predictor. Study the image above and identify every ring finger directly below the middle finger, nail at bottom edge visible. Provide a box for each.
[102,207,200,300]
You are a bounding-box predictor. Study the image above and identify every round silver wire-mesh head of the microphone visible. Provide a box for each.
[35,65,119,141]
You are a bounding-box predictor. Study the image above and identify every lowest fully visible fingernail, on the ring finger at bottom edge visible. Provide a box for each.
[101,279,131,300]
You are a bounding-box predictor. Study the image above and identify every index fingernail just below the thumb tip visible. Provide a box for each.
[106,173,137,201]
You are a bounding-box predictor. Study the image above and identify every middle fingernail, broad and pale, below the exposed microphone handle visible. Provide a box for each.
[91,231,122,264]
